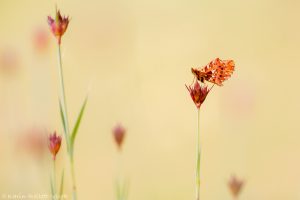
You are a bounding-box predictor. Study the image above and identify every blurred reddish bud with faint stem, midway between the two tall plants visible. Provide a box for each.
[112,124,129,200]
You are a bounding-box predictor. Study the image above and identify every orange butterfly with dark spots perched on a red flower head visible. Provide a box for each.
[192,58,235,86]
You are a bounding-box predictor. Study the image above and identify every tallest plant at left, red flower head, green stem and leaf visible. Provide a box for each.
[48,7,88,200]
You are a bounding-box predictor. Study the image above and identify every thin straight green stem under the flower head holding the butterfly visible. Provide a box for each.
[196,108,201,200]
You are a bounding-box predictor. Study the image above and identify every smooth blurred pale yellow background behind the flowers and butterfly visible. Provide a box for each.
[0,0,300,200]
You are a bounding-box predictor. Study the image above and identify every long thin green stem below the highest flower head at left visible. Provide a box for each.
[58,44,77,200]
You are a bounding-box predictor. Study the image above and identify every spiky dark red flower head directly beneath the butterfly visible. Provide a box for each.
[186,80,210,109]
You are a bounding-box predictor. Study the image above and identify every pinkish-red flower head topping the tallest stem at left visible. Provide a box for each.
[48,10,69,44]
